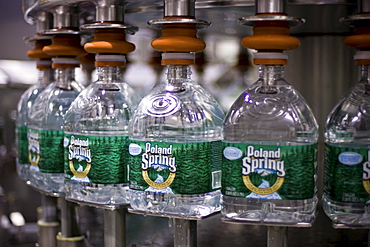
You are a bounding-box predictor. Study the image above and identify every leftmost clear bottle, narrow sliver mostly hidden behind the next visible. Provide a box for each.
[15,69,53,181]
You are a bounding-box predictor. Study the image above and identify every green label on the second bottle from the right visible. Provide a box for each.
[221,142,317,200]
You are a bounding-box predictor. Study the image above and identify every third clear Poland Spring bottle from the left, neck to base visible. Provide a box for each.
[64,67,140,206]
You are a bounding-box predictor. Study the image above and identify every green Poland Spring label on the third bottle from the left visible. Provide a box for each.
[64,134,128,184]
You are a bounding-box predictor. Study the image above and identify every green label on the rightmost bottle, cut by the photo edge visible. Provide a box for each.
[324,144,370,203]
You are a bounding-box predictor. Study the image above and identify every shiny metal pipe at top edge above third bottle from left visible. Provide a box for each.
[96,0,126,22]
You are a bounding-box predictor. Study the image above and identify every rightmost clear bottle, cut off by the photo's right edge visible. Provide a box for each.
[323,66,370,227]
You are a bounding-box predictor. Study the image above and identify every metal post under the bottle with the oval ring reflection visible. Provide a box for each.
[170,218,197,247]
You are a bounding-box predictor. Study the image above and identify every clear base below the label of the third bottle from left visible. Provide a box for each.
[64,179,130,208]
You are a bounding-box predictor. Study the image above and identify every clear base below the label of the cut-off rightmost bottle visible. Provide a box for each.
[323,195,370,228]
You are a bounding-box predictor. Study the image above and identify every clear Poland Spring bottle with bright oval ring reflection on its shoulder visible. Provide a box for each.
[129,65,224,217]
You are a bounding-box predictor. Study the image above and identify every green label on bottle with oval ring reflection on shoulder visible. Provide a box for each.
[129,140,222,194]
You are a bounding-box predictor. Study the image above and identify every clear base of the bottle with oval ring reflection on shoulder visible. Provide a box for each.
[130,190,221,219]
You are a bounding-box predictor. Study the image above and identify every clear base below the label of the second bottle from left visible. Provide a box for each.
[28,169,64,197]
